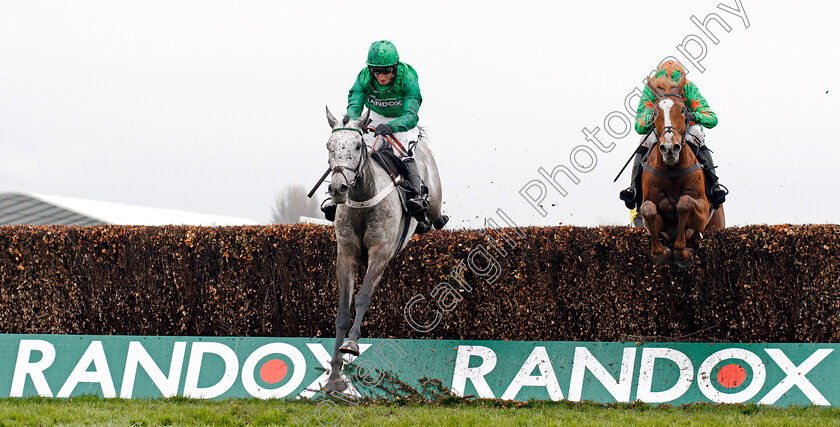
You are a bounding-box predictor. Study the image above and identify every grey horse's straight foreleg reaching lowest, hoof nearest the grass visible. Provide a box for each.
[326,251,358,393]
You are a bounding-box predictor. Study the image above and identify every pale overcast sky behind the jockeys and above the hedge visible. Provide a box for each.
[0,0,840,228]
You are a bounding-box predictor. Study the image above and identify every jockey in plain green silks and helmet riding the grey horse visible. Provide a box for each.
[322,40,429,222]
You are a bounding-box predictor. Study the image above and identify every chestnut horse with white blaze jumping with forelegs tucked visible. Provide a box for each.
[639,76,724,268]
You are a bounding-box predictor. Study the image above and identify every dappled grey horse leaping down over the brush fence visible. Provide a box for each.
[326,108,446,393]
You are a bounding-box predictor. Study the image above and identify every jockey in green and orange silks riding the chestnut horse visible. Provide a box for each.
[619,61,729,209]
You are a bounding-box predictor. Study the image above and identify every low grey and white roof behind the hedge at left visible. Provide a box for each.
[0,193,259,226]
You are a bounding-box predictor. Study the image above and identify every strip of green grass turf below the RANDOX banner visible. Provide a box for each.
[0,397,840,427]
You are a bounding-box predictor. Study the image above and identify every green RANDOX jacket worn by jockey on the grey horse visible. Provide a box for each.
[347,62,423,132]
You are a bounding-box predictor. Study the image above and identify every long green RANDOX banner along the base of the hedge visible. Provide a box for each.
[0,335,840,406]
